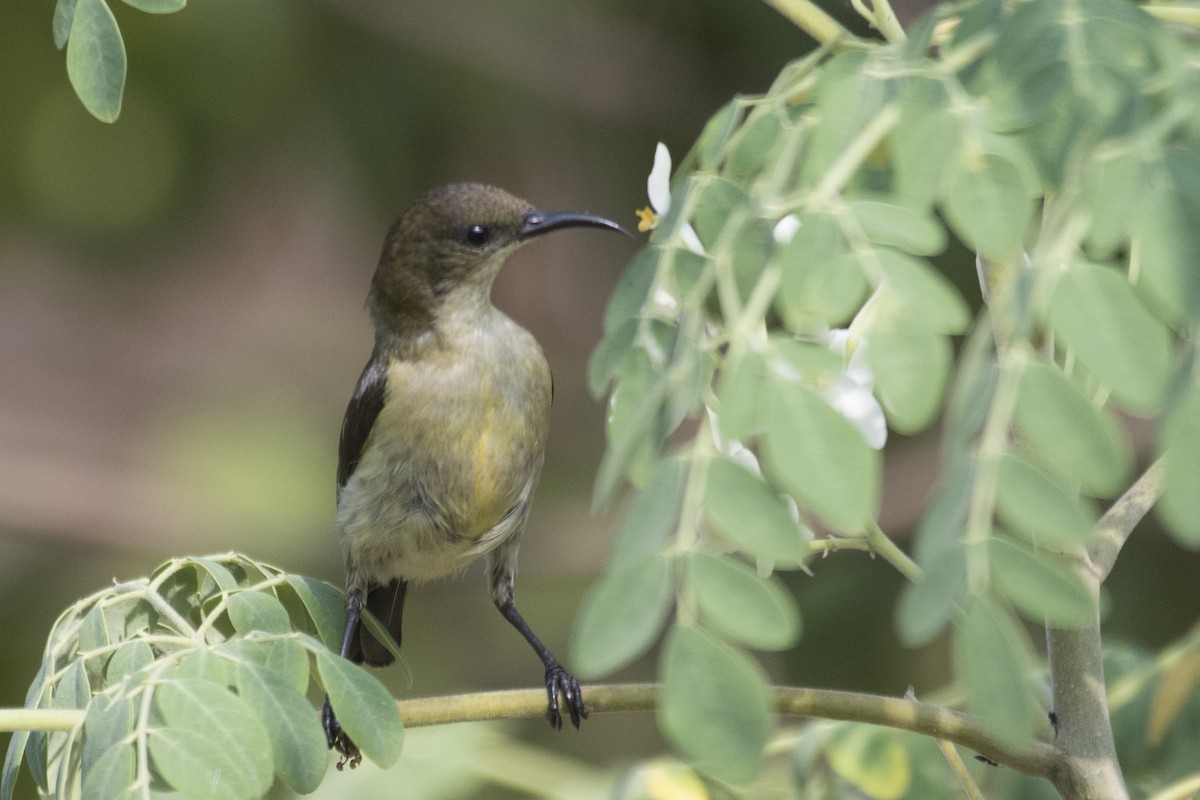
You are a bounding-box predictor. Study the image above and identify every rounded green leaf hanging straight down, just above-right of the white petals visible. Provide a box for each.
[866,313,950,434]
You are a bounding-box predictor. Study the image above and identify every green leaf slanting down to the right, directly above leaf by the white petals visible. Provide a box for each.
[875,247,971,333]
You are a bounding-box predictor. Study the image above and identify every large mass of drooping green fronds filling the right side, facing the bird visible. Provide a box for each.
[575,0,1200,782]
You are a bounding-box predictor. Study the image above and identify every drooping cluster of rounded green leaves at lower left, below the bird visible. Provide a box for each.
[0,554,402,800]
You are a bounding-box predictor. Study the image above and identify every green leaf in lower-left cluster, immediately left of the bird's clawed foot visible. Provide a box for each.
[238,663,328,794]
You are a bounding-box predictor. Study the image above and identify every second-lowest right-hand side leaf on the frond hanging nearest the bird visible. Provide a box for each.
[704,457,812,566]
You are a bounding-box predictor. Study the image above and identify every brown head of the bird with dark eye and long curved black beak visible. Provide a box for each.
[372,184,624,327]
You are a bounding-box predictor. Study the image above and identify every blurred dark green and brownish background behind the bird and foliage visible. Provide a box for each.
[0,0,1200,796]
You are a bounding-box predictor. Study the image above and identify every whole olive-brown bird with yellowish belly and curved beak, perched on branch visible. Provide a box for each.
[324,184,622,754]
